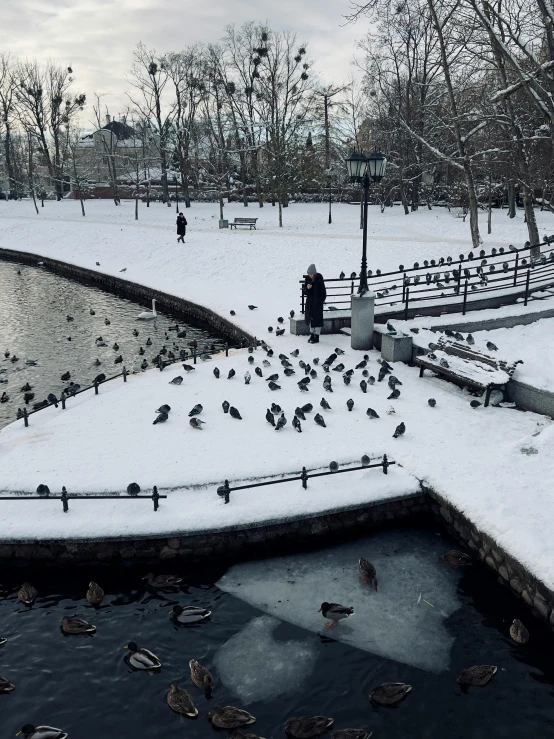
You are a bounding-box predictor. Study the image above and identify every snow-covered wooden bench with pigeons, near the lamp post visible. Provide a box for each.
[414,336,523,407]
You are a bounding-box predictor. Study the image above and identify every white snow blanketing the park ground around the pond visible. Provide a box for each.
[0,201,554,589]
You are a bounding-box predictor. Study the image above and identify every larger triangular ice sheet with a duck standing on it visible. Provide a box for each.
[218,532,460,672]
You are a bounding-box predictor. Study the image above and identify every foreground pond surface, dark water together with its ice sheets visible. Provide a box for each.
[0,527,554,739]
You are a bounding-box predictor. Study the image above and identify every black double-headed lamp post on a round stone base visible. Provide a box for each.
[346,149,387,349]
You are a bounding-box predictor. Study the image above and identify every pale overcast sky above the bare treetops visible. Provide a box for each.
[0,0,367,117]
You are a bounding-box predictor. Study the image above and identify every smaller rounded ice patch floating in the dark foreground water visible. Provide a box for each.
[214,616,318,704]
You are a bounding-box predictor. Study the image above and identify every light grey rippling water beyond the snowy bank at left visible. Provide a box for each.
[0,260,226,428]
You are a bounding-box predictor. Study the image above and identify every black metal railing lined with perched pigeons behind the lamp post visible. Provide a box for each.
[300,236,554,318]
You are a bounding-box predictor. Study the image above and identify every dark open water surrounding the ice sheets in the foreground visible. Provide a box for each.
[0,530,554,739]
